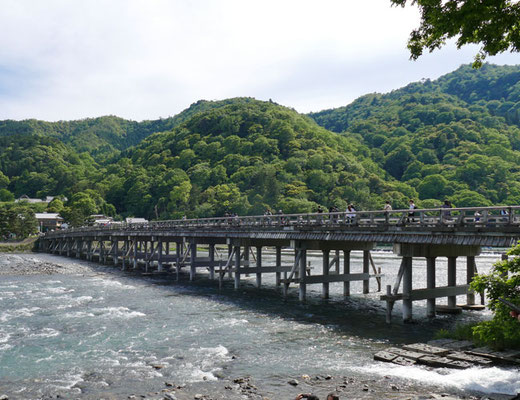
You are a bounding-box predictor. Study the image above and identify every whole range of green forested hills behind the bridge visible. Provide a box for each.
[0,64,520,224]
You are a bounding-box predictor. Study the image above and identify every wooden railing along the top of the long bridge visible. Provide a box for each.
[43,206,520,236]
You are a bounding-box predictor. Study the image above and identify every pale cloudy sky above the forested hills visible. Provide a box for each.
[0,0,520,121]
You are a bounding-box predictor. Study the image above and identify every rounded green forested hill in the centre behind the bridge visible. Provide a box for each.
[104,98,415,218]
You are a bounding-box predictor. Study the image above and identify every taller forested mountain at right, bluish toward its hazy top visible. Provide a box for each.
[310,64,520,206]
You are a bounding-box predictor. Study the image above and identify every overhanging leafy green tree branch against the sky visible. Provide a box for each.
[390,0,520,67]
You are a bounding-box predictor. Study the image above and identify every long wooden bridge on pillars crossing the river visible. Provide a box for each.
[39,206,520,321]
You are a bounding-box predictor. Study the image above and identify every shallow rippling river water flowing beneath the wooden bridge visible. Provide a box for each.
[0,251,520,399]
